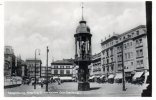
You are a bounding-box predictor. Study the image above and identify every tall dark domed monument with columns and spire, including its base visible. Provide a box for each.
[74,2,92,91]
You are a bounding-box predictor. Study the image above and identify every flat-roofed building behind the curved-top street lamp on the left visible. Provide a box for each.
[26,58,42,78]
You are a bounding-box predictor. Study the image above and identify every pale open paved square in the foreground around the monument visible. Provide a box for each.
[4,82,142,97]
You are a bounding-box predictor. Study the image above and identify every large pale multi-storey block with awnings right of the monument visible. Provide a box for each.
[101,25,149,81]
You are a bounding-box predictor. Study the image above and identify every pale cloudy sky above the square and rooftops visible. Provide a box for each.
[4,1,146,65]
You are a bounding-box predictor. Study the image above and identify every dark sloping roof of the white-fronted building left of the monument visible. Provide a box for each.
[51,59,74,65]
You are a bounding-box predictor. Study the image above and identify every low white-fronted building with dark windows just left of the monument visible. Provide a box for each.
[51,59,76,77]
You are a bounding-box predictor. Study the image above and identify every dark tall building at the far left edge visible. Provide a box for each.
[4,46,16,76]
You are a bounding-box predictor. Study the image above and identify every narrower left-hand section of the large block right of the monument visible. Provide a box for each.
[101,34,117,78]
